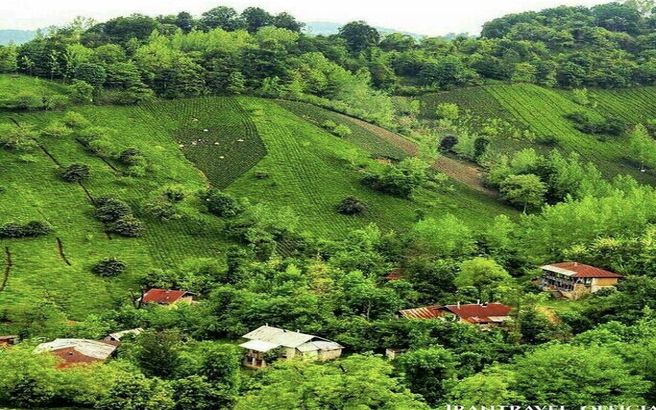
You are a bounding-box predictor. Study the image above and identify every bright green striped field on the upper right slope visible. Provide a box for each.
[422,84,655,182]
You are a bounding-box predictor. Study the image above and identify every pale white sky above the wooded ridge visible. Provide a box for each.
[0,0,612,35]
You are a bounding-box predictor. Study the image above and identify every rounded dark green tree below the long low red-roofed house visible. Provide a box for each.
[397,346,457,405]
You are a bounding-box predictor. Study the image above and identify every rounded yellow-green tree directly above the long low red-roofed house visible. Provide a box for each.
[455,257,512,301]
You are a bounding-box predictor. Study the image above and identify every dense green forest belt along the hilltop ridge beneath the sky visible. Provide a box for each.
[0,2,656,122]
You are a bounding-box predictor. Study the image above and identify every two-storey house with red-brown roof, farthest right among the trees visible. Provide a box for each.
[540,262,623,299]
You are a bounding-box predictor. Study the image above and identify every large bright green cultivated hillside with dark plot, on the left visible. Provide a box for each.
[0,91,514,330]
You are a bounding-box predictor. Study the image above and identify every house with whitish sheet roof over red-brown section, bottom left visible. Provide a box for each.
[34,339,116,368]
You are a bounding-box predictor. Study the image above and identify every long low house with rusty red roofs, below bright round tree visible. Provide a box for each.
[399,303,512,328]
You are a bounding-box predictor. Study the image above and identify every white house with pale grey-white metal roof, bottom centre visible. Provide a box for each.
[239,325,344,369]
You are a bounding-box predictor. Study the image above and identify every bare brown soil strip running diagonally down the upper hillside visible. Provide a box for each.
[340,114,497,196]
